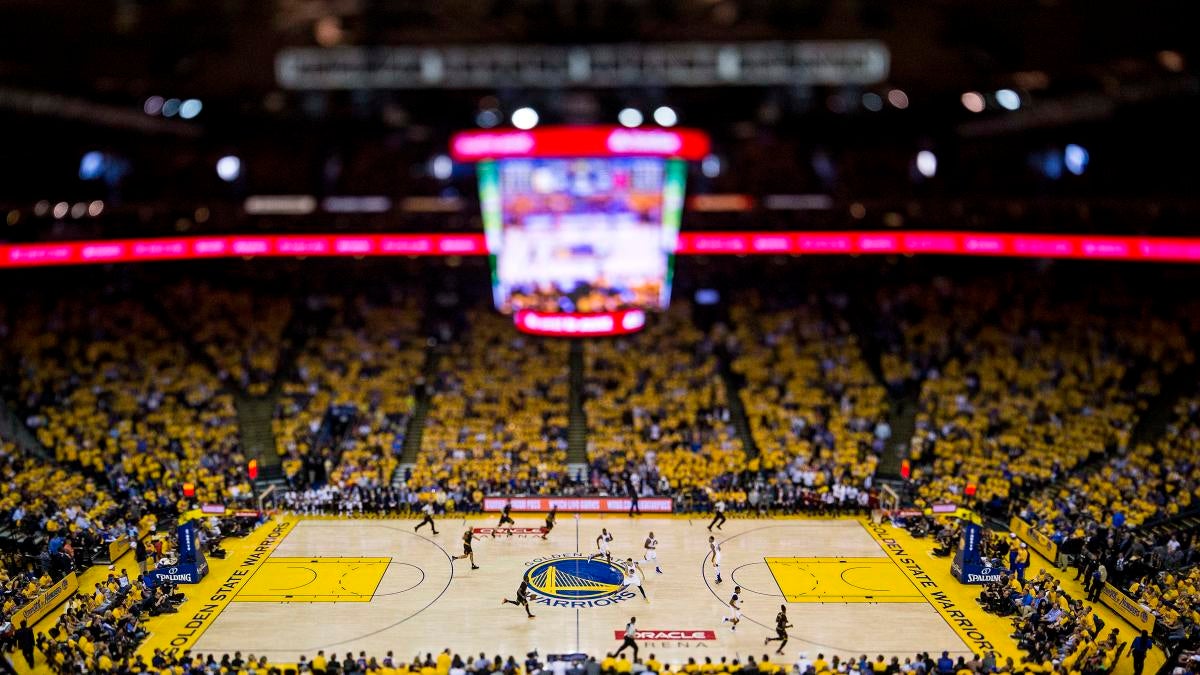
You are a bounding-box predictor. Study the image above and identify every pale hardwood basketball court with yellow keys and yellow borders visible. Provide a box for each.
[133,514,1015,662]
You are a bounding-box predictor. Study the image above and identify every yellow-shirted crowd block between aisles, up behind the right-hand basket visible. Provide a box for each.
[881,276,1192,509]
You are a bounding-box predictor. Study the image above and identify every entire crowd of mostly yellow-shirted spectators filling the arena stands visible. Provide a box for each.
[0,269,1200,675]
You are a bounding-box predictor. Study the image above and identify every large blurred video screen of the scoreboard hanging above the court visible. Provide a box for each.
[478,157,686,313]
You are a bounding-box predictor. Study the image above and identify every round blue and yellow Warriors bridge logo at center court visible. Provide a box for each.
[524,554,635,609]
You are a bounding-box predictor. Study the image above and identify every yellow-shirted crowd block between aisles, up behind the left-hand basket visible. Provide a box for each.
[6,297,250,510]
